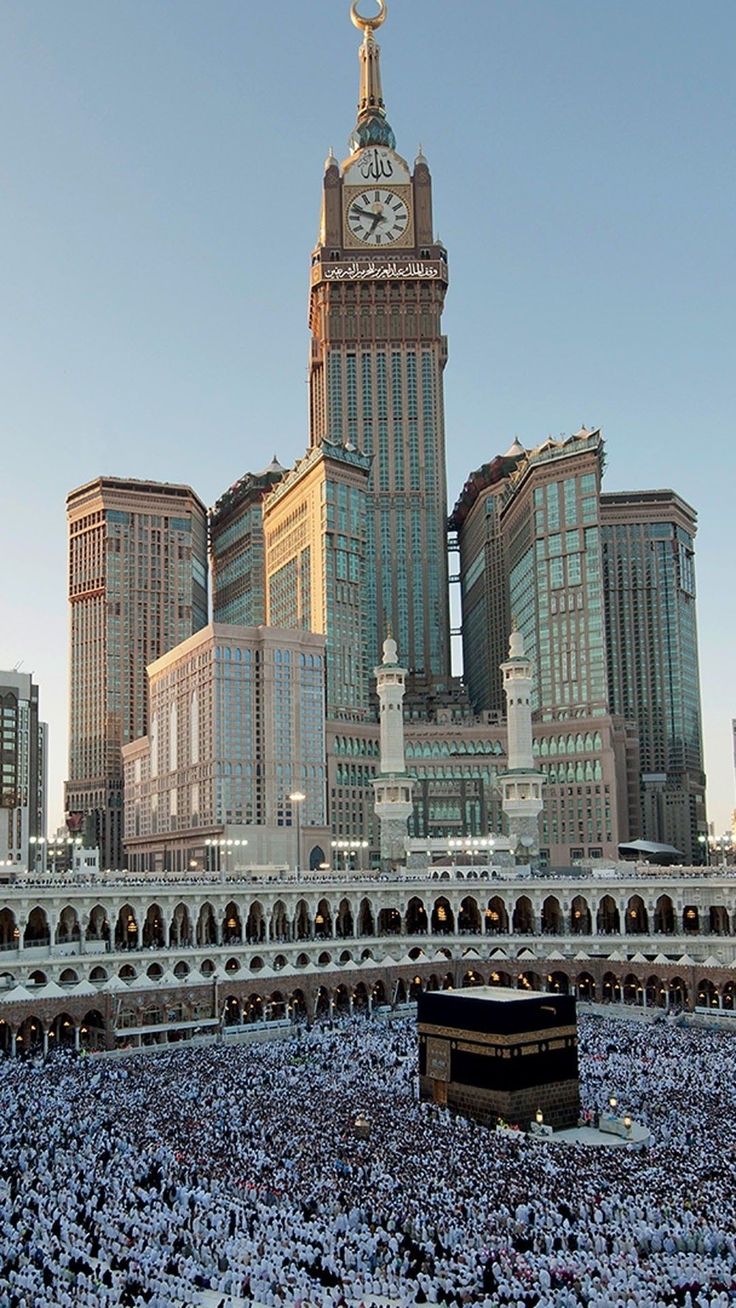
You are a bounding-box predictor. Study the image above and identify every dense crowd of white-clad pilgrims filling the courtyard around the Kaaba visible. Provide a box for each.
[0,1016,736,1308]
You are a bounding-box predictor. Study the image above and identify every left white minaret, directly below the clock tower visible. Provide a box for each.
[373,636,412,863]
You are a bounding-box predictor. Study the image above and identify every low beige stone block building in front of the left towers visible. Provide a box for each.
[123,623,328,874]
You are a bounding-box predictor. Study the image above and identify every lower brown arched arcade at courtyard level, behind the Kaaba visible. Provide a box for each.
[0,950,736,1057]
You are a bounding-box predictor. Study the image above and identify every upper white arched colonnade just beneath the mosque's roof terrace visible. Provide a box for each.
[0,886,736,956]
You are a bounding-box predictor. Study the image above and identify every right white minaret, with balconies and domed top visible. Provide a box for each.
[498,628,544,863]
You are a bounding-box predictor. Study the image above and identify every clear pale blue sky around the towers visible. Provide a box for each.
[0,0,736,831]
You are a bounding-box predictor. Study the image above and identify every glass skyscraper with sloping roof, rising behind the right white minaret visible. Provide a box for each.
[450,426,608,721]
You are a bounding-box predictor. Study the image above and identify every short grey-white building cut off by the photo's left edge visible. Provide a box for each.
[0,670,47,870]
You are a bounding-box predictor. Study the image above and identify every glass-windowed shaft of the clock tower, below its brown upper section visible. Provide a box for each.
[311,332,448,678]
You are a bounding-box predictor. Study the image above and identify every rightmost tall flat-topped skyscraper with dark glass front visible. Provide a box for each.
[600,491,707,863]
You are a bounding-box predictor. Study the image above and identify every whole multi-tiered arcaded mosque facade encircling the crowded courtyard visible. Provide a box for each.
[0,855,736,1056]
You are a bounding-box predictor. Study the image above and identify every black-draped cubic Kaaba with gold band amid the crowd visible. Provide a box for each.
[417,986,580,1130]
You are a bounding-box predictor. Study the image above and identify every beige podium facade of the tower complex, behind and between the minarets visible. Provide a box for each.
[327,709,638,867]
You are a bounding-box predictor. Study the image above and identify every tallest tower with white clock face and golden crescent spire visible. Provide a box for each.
[310,0,450,691]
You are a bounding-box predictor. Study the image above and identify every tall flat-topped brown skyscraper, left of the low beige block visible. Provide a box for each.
[65,477,208,867]
